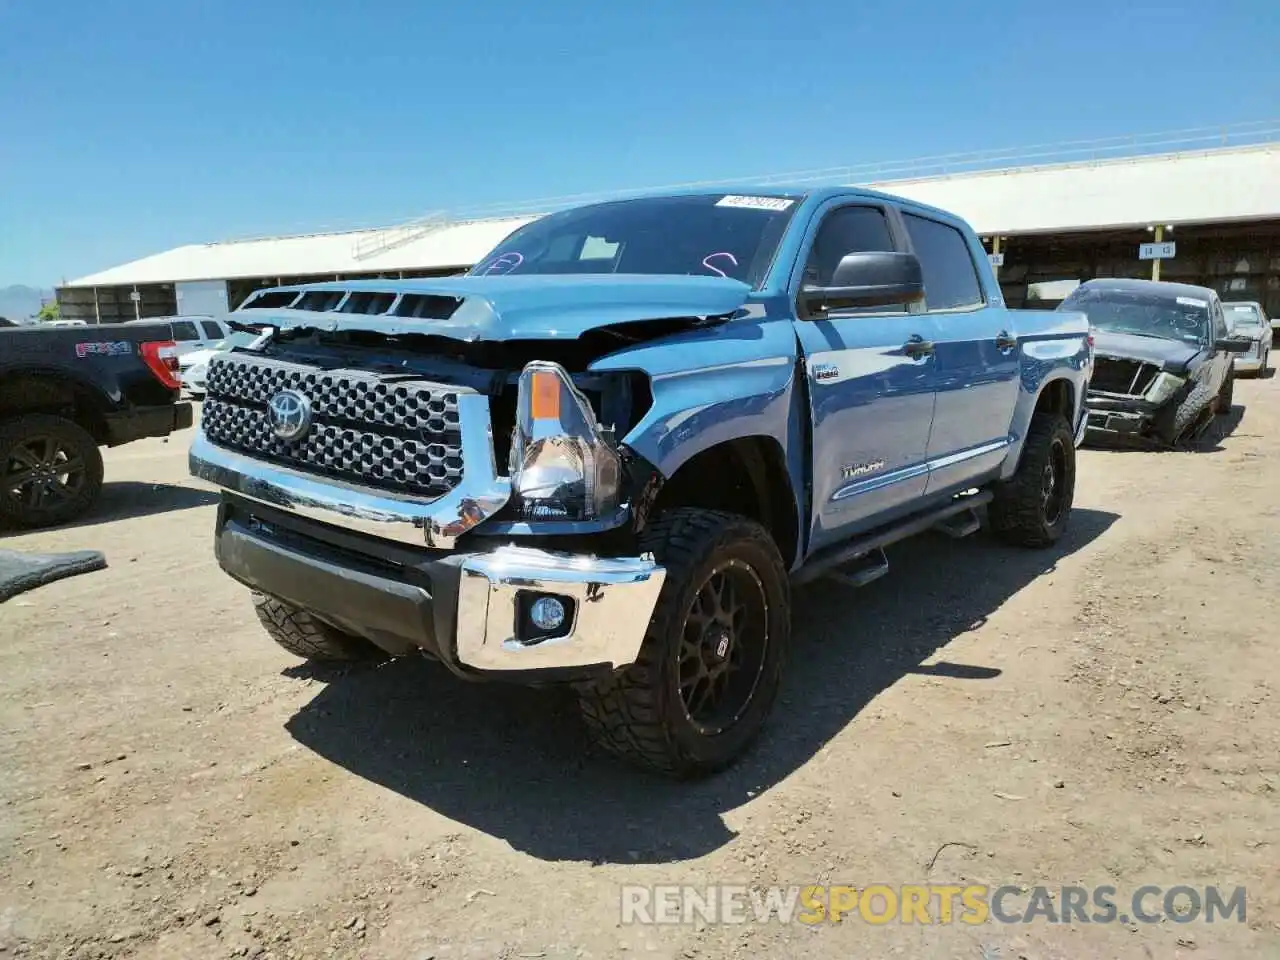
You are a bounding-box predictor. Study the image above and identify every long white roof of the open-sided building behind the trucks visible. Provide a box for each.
[64,136,1280,289]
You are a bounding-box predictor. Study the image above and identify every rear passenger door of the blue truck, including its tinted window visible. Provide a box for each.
[902,209,1020,494]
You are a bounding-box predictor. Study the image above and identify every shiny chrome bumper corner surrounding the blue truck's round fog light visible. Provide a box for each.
[456,547,667,673]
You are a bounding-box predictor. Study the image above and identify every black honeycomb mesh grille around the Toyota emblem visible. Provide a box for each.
[201,353,463,497]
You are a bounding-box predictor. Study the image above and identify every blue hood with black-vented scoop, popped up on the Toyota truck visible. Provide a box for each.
[249,274,751,340]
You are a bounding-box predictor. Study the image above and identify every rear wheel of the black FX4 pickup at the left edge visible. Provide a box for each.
[0,413,102,527]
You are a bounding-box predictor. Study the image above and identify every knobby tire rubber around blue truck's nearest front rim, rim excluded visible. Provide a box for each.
[579,508,791,778]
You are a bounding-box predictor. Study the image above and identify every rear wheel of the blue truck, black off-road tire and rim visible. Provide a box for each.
[987,413,1075,547]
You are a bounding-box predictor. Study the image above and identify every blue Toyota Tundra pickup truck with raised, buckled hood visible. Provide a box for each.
[189,188,1092,777]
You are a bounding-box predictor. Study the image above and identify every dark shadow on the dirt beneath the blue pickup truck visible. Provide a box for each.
[287,508,1116,863]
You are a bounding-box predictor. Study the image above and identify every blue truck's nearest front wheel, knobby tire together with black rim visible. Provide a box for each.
[579,508,791,778]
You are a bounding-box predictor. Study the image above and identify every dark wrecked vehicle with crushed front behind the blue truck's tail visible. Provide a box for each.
[1059,279,1249,447]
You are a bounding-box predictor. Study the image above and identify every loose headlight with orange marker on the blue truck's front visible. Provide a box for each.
[509,360,620,520]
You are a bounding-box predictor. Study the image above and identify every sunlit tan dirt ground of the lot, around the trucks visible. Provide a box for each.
[0,379,1280,960]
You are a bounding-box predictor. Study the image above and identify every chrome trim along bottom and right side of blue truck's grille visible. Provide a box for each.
[187,394,511,549]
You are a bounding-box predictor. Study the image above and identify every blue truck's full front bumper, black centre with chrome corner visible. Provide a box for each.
[214,497,667,680]
